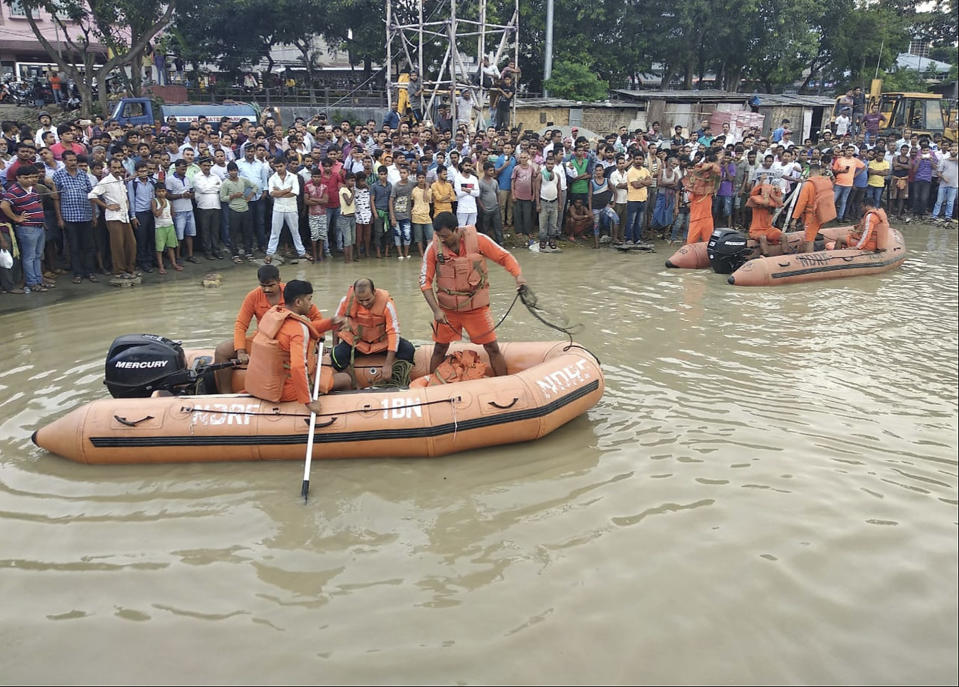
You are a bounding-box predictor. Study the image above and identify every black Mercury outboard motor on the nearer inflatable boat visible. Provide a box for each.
[103,334,195,398]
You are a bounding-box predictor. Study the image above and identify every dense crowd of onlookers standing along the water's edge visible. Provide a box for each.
[0,99,957,293]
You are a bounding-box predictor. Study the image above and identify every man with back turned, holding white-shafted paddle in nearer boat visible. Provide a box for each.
[246,279,350,413]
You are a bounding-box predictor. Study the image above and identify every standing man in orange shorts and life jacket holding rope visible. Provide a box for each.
[420,212,526,376]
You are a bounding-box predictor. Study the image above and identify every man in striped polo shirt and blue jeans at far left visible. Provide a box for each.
[0,164,53,293]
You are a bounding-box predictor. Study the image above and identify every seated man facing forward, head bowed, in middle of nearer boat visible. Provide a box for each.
[330,278,416,388]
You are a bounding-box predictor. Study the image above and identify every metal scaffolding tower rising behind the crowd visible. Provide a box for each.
[386,0,519,128]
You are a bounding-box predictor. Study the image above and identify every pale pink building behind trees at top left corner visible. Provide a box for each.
[0,2,106,80]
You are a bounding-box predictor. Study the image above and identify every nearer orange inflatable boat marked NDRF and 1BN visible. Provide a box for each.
[33,337,605,463]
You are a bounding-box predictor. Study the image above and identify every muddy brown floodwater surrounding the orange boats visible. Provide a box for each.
[0,224,959,685]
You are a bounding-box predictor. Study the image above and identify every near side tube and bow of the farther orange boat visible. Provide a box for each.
[728,227,906,286]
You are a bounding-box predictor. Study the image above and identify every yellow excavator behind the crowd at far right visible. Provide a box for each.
[833,79,959,142]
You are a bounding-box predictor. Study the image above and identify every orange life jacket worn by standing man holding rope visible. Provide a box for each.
[433,226,489,311]
